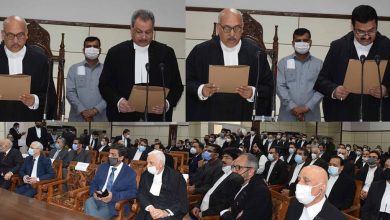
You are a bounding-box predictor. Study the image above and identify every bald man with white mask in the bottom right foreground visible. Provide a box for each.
[286,165,347,220]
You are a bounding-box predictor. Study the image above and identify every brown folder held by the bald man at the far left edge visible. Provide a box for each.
[0,74,31,101]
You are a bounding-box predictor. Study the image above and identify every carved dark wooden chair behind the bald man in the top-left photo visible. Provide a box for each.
[27,20,65,119]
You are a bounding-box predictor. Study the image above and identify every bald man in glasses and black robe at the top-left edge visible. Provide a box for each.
[0,16,56,121]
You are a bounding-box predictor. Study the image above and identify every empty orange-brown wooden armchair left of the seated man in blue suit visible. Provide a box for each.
[47,161,98,212]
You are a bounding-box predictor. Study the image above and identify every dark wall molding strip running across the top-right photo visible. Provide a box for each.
[186,6,390,21]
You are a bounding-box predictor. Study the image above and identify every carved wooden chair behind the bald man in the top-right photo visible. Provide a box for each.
[212,11,279,114]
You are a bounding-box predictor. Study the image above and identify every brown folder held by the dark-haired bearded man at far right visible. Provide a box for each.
[343,59,388,94]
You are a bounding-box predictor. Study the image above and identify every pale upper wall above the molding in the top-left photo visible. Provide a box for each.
[0,0,185,28]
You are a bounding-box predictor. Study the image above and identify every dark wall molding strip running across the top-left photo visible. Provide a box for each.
[0,17,186,33]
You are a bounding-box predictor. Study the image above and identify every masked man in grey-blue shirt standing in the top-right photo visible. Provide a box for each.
[276,28,323,121]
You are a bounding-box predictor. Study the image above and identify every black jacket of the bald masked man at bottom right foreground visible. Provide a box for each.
[286,199,347,220]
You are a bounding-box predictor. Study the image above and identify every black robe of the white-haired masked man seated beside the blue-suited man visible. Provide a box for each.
[136,167,188,220]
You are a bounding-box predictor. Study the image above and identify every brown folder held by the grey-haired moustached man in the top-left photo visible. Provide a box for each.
[129,85,169,113]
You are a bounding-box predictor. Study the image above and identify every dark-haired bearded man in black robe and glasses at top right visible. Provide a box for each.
[314,5,390,121]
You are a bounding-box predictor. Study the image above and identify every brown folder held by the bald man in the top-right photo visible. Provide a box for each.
[209,65,249,93]
